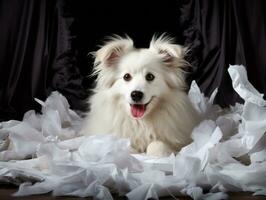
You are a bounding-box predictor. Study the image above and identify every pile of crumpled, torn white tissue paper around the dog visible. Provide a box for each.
[0,65,266,200]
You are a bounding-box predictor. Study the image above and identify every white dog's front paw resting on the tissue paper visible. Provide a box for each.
[146,141,174,157]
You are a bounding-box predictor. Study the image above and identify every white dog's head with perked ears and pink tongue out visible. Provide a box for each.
[92,36,188,118]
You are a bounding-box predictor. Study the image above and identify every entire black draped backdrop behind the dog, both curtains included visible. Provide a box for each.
[0,0,266,120]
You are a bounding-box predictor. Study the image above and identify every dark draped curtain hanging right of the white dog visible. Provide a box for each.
[179,0,266,106]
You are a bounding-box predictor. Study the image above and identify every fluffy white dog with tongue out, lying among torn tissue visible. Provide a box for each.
[83,36,200,157]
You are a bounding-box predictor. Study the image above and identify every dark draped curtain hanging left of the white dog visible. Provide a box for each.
[0,0,86,120]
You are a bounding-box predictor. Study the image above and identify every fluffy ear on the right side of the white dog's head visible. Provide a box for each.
[150,34,188,67]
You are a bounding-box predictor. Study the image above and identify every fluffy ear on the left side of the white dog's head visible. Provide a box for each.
[94,36,134,67]
